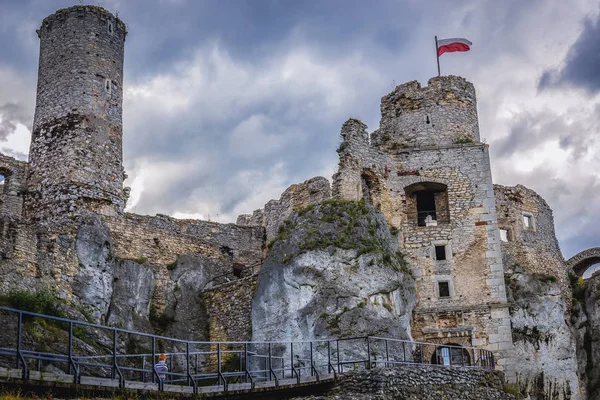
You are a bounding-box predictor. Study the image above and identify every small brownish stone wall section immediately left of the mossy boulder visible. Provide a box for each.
[202,275,258,342]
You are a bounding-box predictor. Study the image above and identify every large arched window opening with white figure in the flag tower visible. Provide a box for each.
[405,182,450,226]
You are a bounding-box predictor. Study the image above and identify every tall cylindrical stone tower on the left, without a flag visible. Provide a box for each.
[25,6,127,220]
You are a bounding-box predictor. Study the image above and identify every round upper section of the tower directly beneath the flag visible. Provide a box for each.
[372,76,479,150]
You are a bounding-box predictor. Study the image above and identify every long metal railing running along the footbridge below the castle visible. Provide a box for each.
[0,307,495,393]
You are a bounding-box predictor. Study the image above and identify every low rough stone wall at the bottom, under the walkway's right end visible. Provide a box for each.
[298,365,516,400]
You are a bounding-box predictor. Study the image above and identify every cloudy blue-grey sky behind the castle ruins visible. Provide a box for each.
[0,0,600,257]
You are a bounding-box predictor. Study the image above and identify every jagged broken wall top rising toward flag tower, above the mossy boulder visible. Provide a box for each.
[237,176,331,242]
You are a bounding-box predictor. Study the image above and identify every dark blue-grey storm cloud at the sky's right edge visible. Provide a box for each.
[539,14,600,93]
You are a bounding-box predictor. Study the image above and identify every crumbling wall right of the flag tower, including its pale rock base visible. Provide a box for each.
[494,185,583,399]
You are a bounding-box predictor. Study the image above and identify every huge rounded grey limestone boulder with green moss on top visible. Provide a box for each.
[252,201,416,341]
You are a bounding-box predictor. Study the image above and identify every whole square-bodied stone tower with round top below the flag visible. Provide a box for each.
[333,76,514,377]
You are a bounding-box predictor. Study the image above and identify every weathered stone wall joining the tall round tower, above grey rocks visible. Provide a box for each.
[106,214,264,311]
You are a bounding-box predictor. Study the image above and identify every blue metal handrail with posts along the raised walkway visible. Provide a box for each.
[0,307,495,393]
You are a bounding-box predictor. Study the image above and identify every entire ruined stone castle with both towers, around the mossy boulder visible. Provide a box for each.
[0,6,597,399]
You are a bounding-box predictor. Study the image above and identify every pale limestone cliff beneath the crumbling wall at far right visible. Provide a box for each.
[506,264,583,400]
